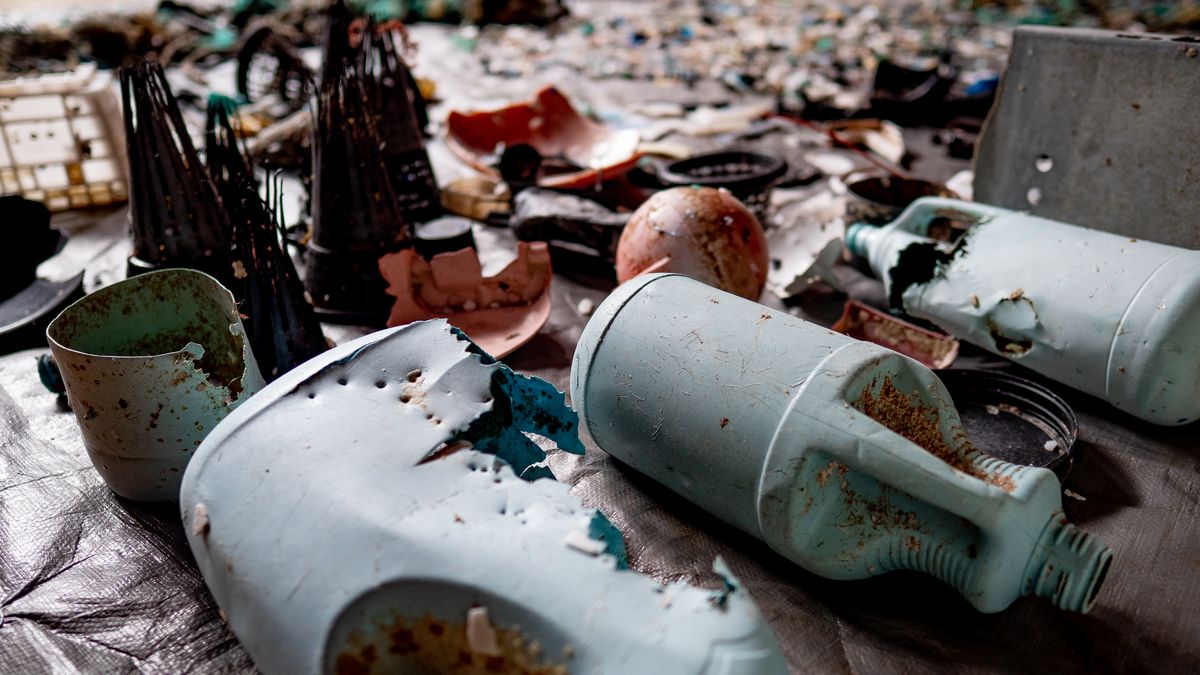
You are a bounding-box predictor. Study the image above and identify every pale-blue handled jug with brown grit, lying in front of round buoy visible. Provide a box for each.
[571,275,1112,611]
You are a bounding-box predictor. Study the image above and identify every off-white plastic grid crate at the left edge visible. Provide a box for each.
[0,64,128,211]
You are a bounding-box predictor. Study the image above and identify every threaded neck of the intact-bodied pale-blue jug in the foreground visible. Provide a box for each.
[1025,514,1112,613]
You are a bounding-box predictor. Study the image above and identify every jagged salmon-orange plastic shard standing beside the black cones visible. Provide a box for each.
[379,241,553,358]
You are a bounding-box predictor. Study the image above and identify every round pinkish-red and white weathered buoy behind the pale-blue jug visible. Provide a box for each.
[617,187,768,300]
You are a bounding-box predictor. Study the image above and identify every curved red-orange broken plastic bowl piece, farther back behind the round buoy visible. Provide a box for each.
[446,86,642,187]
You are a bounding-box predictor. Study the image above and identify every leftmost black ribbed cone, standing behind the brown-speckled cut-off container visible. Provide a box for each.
[121,62,230,286]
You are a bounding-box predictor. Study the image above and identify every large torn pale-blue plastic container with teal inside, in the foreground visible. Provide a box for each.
[181,321,786,675]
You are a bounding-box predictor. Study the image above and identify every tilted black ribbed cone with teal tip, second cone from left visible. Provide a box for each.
[205,101,329,381]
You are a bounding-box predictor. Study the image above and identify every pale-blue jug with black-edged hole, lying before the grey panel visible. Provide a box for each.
[846,198,1200,425]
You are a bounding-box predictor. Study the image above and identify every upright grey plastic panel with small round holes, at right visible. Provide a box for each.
[974,25,1200,249]
